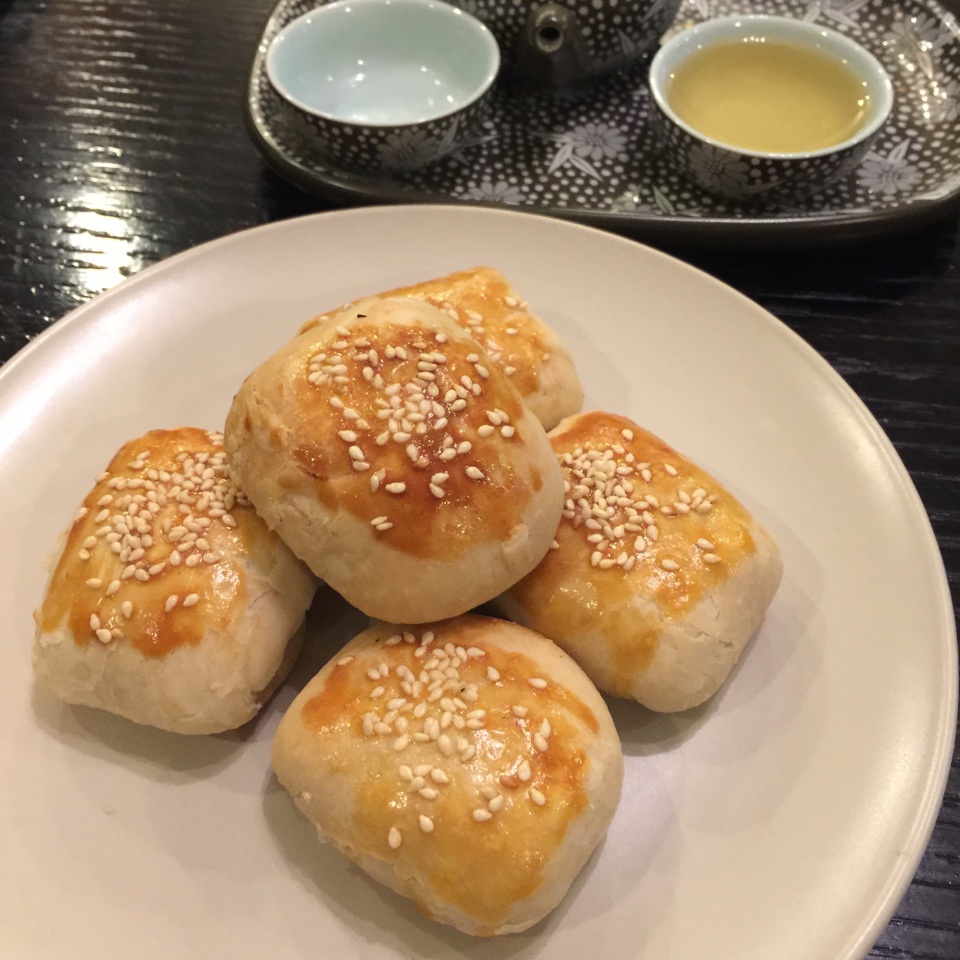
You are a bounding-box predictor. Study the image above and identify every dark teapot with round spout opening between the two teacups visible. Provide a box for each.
[450,0,681,86]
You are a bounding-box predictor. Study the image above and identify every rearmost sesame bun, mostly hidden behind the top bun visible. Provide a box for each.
[301,267,583,430]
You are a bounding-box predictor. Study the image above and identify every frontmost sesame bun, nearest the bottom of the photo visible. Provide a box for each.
[273,615,623,936]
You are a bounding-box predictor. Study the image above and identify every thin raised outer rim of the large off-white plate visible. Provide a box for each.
[0,204,958,960]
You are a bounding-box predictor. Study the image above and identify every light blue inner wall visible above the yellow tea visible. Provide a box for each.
[650,14,893,158]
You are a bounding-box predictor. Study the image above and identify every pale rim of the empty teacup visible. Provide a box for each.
[263,0,501,130]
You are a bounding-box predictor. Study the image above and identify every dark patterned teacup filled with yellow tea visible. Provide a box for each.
[649,15,894,202]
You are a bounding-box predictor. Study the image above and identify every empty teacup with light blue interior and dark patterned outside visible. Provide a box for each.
[266,0,500,173]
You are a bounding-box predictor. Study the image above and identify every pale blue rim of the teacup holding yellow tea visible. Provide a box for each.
[648,13,894,160]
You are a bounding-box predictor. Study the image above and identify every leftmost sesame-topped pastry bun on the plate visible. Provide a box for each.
[33,427,316,733]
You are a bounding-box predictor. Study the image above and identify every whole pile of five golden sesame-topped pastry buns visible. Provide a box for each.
[34,267,781,936]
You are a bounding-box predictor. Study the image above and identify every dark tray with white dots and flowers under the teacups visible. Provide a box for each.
[246,0,960,244]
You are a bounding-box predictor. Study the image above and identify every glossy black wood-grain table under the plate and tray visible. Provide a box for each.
[0,0,960,960]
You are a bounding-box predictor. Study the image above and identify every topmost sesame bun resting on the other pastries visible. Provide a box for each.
[226,299,563,623]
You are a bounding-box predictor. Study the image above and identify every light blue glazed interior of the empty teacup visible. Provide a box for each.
[266,0,500,126]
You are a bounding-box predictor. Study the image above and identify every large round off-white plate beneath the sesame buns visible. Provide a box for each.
[0,207,956,960]
